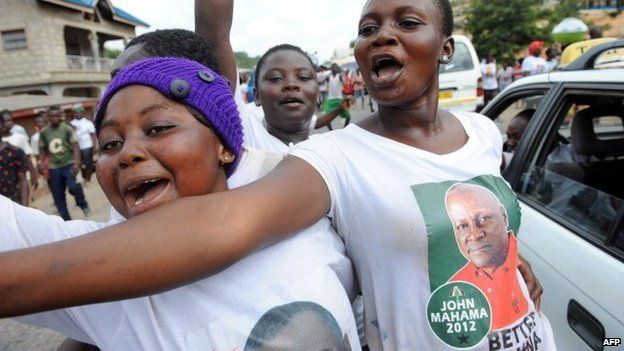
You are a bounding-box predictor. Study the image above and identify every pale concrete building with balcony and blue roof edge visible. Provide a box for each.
[0,0,148,98]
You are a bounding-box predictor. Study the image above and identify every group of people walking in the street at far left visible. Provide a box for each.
[0,105,92,220]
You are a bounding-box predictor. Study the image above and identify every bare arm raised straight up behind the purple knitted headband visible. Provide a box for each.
[195,0,238,90]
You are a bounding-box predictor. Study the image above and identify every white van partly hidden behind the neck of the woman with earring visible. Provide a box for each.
[439,35,483,111]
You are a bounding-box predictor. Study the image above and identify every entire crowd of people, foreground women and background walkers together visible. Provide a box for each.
[0,0,556,350]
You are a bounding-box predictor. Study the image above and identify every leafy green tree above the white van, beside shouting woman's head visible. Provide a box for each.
[465,0,549,62]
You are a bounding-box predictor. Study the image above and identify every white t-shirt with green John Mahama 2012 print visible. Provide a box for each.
[291,112,555,351]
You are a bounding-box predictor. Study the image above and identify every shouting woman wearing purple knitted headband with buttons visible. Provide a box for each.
[0,58,359,351]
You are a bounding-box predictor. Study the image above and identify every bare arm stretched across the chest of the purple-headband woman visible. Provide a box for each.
[0,156,330,317]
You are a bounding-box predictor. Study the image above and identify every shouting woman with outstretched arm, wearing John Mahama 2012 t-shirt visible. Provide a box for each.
[0,0,555,350]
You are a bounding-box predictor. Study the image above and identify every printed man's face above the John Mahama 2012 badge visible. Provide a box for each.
[445,183,509,268]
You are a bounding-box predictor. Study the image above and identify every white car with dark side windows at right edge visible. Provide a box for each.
[482,40,624,351]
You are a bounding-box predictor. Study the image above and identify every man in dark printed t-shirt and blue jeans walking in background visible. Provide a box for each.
[39,106,91,221]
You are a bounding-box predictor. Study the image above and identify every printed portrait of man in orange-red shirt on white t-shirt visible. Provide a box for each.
[445,183,529,330]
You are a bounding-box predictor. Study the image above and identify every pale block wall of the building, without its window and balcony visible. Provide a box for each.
[0,0,135,95]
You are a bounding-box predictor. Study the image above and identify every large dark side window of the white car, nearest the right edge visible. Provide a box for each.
[517,95,624,249]
